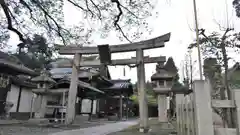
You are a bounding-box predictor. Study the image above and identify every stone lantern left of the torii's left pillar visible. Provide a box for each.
[32,71,56,118]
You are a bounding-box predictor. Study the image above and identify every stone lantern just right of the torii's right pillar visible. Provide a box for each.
[151,62,176,122]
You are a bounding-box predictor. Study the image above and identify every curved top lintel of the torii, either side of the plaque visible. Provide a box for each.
[59,33,171,55]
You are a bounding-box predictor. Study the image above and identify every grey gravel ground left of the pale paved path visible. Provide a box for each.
[0,121,116,135]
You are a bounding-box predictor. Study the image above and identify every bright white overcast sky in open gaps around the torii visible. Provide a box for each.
[6,0,240,82]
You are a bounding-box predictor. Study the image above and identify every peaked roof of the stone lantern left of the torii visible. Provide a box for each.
[31,70,56,84]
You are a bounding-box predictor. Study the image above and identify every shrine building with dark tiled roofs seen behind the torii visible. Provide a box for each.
[29,59,133,121]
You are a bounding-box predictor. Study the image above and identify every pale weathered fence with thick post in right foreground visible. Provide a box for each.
[176,80,240,135]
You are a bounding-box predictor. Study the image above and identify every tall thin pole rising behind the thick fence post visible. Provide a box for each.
[193,0,203,80]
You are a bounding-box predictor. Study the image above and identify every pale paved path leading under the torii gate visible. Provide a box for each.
[51,120,138,135]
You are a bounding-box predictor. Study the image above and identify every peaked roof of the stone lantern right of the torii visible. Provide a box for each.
[151,62,177,81]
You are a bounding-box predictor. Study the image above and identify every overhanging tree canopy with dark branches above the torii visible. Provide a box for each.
[0,0,155,47]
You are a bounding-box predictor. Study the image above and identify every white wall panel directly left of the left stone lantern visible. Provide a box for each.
[19,88,33,112]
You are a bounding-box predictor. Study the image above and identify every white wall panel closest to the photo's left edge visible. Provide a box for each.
[7,84,19,112]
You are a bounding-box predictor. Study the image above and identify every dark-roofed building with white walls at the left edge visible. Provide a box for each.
[0,52,38,119]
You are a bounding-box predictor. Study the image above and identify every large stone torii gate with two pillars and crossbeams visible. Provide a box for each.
[59,33,170,131]
